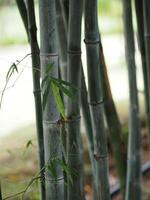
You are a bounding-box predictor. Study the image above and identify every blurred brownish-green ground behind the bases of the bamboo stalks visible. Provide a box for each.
[0,125,150,200]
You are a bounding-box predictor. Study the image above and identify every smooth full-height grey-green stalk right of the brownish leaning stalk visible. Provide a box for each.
[123,0,141,200]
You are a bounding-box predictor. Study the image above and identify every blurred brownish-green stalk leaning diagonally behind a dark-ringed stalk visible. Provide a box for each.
[100,41,126,195]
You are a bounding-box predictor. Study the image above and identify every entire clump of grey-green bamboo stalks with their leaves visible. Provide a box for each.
[2,0,150,200]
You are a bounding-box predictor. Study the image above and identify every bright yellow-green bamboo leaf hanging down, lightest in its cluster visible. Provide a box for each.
[51,80,65,119]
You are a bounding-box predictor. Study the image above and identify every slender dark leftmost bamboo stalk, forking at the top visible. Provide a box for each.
[16,0,45,200]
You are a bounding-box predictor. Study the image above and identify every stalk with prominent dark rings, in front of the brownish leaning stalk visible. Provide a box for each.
[84,0,110,200]
